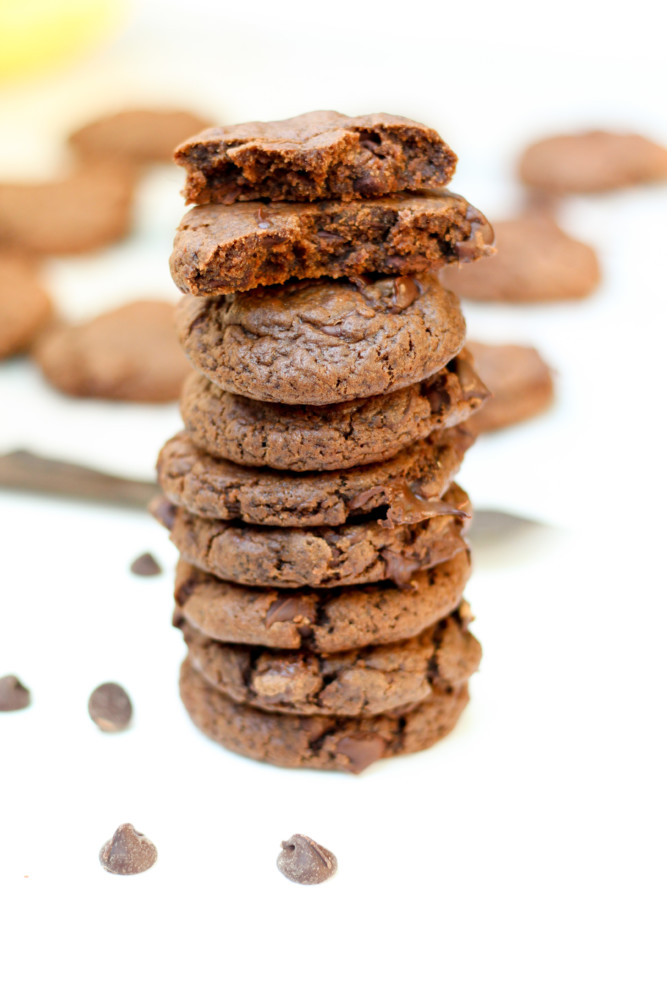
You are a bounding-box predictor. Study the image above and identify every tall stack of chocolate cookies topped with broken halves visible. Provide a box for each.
[154,112,492,772]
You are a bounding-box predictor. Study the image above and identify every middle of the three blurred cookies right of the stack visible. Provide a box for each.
[440,213,600,302]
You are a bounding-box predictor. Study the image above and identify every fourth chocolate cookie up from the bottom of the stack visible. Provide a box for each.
[165,485,470,588]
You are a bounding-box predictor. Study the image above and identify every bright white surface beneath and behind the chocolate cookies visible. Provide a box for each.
[0,0,667,1000]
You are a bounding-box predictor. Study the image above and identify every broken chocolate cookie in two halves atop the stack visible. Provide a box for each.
[171,111,493,295]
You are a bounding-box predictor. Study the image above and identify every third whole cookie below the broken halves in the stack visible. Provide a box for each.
[158,427,474,527]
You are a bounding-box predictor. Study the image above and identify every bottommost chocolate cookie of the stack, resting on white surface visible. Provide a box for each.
[180,660,468,774]
